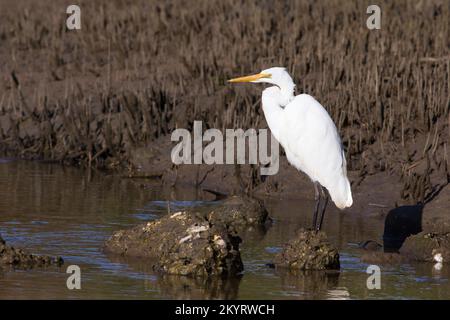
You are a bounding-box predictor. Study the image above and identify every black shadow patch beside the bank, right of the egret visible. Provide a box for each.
[383,204,423,252]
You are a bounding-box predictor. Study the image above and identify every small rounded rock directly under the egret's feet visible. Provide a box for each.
[274,230,340,270]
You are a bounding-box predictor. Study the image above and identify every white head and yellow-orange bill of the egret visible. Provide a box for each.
[228,67,295,89]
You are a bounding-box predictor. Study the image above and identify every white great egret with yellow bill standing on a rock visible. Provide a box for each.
[228,67,353,230]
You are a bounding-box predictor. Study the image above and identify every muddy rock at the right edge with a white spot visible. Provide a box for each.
[400,232,450,263]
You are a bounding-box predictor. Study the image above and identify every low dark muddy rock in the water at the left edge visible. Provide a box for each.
[0,236,64,269]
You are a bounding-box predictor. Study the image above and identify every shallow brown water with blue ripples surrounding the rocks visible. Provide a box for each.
[0,159,450,299]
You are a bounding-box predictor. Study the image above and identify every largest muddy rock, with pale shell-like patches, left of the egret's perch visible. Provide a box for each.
[105,211,243,276]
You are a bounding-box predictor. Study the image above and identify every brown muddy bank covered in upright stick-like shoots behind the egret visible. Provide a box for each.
[0,0,450,202]
